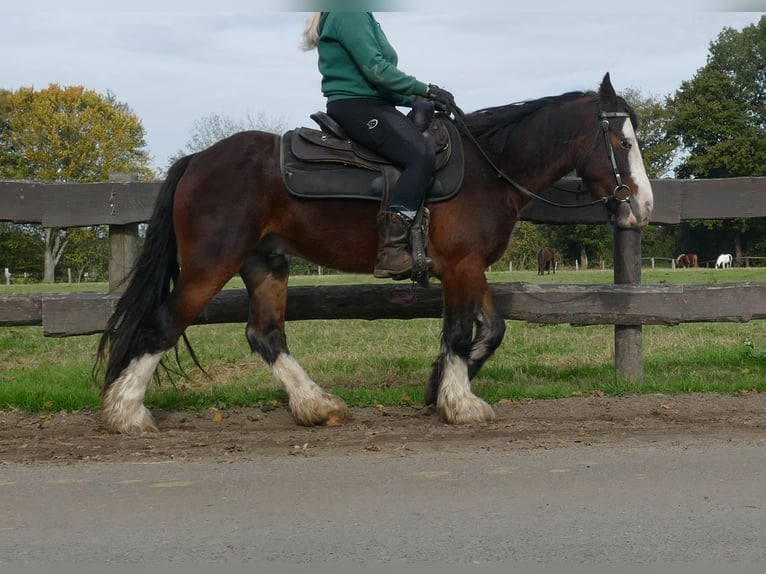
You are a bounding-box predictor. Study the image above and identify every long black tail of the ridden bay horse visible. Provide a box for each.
[94,156,192,389]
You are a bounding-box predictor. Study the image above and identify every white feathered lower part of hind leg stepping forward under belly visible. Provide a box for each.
[272,353,348,426]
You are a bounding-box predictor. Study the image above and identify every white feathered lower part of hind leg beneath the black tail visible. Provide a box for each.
[101,352,165,434]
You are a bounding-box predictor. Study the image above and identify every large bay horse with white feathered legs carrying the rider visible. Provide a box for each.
[94,73,653,433]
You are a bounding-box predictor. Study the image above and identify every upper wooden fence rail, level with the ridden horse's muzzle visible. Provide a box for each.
[0,177,766,227]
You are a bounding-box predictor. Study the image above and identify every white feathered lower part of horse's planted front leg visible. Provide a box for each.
[436,355,495,424]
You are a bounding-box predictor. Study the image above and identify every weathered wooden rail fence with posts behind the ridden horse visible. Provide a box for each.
[0,177,766,380]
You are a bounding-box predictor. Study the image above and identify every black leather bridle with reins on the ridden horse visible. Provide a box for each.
[447,105,631,212]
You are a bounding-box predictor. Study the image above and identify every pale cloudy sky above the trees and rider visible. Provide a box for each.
[0,0,766,171]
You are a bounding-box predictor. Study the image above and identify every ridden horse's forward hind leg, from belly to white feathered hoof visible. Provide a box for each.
[240,250,349,426]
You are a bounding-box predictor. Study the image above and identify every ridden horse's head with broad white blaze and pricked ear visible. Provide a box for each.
[578,73,654,228]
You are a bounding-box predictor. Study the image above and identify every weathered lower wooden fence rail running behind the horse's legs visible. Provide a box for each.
[0,282,766,337]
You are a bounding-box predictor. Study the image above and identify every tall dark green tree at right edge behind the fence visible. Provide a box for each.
[668,16,766,264]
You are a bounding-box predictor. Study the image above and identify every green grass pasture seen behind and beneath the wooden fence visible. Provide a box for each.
[0,268,766,412]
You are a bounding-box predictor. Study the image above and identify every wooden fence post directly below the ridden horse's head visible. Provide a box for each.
[614,226,644,381]
